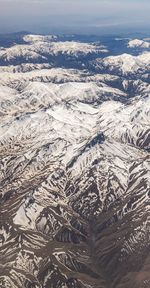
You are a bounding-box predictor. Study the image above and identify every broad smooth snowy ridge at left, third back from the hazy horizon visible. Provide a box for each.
[0,81,127,117]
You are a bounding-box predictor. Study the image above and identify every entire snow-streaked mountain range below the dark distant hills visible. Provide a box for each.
[0,35,150,288]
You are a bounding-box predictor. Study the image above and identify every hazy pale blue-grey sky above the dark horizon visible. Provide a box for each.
[0,0,150,34]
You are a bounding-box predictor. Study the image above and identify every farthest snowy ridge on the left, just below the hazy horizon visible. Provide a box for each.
[0,35,107,63]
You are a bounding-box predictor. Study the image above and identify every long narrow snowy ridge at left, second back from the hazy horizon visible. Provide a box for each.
[0,64,119,89]
